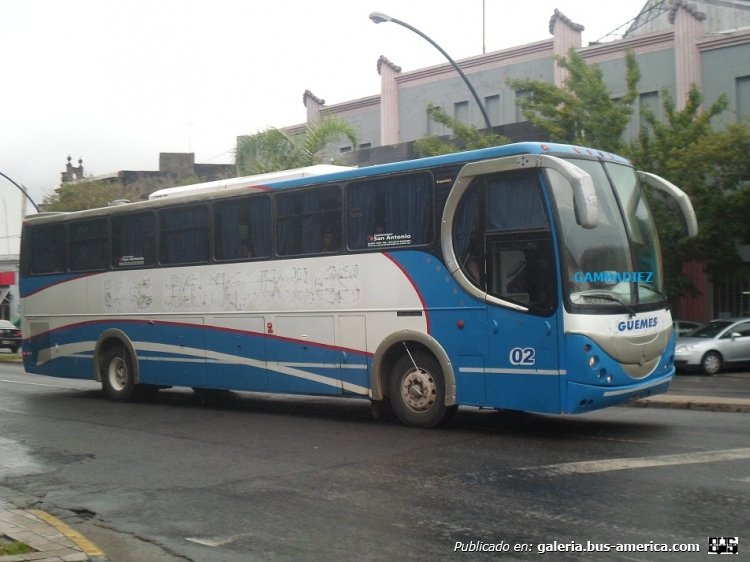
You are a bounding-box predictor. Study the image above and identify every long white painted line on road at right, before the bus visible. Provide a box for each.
[521,447,750,476]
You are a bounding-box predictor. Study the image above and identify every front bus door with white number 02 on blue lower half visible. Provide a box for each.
[480,170,560,412]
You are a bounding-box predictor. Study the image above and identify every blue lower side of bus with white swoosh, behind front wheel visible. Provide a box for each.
[29,320,371,395]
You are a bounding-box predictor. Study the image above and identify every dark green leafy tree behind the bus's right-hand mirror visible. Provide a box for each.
[630,87,750,295]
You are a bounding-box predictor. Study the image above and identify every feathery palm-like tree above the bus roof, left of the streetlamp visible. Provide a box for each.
[236,117,358,176]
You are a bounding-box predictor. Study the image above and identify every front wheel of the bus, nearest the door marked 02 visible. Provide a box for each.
[390,351,448,429]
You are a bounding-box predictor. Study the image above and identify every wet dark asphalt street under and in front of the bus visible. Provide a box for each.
[0,364,750,562]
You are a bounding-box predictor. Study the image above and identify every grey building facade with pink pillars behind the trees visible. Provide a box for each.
[280,0,750,321]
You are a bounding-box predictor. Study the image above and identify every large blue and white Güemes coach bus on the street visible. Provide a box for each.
[20,142,697,428]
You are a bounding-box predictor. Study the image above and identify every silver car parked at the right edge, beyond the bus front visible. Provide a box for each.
[674,317,750,375]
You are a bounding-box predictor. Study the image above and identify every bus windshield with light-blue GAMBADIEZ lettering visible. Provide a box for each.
[549,160,665,309]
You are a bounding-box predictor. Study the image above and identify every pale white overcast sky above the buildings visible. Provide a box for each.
[0,0,645,208]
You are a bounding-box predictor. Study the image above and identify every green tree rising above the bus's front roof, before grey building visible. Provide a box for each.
[508,49,640,152]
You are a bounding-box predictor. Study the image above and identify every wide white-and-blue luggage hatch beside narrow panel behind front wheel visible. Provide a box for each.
[266,315,342,394]
